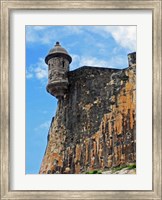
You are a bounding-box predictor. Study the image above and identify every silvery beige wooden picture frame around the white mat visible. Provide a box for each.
[0,0,162,200]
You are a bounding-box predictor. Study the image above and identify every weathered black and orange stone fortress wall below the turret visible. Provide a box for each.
[39,53,136,174]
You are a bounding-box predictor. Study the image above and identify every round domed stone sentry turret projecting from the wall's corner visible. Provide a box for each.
[45,42,72,99]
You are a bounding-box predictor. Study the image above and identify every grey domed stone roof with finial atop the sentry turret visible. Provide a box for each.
[45,42,72,64]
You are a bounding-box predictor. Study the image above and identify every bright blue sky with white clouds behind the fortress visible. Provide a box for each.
[26,26,136,174]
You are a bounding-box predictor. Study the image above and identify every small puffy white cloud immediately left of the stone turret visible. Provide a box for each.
[26,58,48,80]
